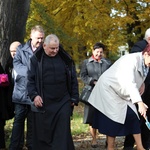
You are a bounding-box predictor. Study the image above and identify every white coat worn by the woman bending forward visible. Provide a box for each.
[89,52,145,124]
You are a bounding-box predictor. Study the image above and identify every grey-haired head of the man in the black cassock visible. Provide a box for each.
[43,34,59,57]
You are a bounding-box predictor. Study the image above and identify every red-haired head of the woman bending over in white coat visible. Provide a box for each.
[142,44,150,67]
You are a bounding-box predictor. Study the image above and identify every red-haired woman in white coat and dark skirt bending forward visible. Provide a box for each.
[89,45,150,150]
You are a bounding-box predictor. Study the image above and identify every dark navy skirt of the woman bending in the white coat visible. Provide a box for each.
[92,106,141,137]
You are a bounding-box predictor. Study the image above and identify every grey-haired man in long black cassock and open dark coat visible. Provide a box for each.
[28,34,79,150]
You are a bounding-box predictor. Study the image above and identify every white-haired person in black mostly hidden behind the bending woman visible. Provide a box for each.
[124,28,150,150]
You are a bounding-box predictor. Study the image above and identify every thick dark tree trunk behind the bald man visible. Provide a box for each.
[0,0,30,68]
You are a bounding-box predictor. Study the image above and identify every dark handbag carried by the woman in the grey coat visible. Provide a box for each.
[79,85,93,105]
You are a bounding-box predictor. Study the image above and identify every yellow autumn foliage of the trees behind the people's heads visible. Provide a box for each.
[27,0,150,63]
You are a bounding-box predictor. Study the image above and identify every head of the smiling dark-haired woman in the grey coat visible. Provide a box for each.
[92,42,105,60]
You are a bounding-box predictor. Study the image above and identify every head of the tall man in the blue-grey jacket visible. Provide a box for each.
[30,25,44,48]
